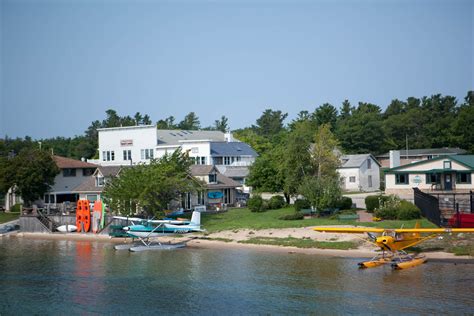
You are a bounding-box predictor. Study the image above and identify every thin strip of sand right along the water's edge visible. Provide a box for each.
[5,232,474,264]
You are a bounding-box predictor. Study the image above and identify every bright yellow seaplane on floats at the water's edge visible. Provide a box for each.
[314,223,474,269]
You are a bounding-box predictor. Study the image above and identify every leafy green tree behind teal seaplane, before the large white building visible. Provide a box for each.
[104,150,198,217]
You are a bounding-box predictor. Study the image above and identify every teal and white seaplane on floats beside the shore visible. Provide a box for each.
[114,211,205,252]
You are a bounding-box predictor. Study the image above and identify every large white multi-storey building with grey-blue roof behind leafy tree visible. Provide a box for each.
[89,125,257,166]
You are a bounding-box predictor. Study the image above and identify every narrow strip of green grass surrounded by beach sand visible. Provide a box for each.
[239,237,357,250]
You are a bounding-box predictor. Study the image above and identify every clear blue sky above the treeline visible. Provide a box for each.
[0,0,474,139]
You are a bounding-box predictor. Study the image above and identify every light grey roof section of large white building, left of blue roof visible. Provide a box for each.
[156,129,225,145]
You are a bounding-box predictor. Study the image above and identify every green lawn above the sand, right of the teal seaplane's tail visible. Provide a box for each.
[202,207,436,233]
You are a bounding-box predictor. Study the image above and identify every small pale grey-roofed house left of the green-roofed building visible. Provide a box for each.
[337,154,380,192]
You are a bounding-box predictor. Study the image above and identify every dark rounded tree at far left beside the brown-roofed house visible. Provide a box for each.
[0,148,59,205]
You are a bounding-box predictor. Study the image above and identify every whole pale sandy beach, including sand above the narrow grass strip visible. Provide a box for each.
[3,227,474,263]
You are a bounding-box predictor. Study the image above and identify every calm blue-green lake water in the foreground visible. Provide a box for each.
[0,238,474,315]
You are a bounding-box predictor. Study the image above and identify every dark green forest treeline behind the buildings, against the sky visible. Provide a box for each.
[0,91,474,159]
